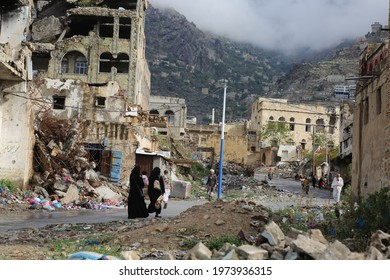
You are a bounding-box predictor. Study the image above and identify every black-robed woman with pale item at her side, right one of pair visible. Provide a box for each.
[148,167,165,218]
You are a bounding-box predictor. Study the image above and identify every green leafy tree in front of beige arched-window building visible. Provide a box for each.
[260,122,291,146]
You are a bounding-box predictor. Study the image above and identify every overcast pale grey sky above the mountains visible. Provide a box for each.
[149,0,389,53]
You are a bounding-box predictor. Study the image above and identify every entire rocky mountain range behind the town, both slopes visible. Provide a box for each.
[145,5,387,123]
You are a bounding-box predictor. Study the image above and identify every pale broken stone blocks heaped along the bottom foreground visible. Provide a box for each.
[117,201,390,260]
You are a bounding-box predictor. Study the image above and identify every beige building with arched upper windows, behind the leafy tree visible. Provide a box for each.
[250,97,340,164]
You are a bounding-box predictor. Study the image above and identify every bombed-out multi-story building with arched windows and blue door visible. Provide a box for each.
[0,0,159,188]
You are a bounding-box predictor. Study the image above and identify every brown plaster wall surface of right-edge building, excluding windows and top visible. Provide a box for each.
[352,55,389,198]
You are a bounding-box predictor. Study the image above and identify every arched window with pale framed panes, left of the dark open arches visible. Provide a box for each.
[60,51,88,75]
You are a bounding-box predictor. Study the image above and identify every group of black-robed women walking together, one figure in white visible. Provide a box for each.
[127,165,173,219]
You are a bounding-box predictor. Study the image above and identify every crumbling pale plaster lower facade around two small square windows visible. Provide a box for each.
[36,79,152,184]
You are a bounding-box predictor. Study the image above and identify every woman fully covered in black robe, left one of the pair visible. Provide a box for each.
[127,165,149,219]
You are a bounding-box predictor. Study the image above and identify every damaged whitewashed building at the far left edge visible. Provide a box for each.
[0,0,34,186]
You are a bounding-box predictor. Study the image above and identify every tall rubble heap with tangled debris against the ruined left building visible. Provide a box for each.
[0,112,127,210]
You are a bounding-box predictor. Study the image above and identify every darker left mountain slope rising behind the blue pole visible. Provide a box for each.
[145,5,289,123]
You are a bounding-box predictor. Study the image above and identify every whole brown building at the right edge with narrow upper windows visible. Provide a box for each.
[352,43,390,198]
